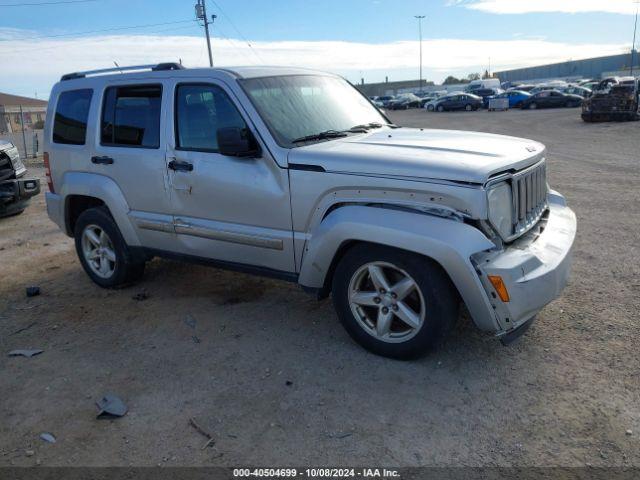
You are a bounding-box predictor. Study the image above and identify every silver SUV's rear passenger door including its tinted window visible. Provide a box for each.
[91,79,175,249]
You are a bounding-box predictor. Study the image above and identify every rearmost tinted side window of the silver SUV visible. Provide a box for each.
[53,88,93,145]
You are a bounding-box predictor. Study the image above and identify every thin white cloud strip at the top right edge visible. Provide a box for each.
[448,0,636,15]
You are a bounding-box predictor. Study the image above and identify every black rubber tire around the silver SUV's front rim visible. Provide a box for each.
[332,244,460,360]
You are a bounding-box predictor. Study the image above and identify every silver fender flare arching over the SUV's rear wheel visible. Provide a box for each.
[58,172,140,246]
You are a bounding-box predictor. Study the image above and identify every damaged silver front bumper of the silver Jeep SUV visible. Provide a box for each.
[474,191,577,335]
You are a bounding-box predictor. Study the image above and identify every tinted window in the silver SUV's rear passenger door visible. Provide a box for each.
[100,85,162,148]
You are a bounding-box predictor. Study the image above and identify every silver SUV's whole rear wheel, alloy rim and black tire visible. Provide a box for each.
[74,207,144,288]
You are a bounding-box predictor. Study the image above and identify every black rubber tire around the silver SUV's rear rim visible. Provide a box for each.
[74,207,145,288]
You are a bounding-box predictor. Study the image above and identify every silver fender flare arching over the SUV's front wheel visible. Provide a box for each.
[299,206,500,332]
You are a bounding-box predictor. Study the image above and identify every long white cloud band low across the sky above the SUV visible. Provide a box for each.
[0,32,627,97]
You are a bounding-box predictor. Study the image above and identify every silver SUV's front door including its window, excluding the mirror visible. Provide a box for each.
[167,79,295,272]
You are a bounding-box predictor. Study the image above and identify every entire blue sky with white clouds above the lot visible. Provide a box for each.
[0,0,640,99]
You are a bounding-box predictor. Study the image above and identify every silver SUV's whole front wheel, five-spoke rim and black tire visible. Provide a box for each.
[332,244,459,359]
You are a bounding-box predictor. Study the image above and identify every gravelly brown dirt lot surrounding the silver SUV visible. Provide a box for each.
[0,109,640,466]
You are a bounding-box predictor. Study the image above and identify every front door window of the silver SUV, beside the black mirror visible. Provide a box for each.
[175,84,247,152]
